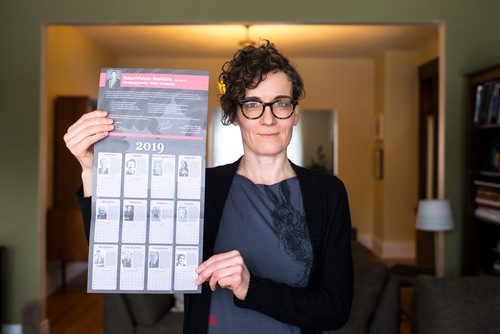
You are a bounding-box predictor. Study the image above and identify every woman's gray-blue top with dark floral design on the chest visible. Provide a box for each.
[208,174,312,334]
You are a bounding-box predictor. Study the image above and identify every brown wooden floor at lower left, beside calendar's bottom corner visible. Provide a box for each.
[47,273,103,334]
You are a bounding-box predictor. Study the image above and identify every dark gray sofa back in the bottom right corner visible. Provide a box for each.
[412,276,500,334]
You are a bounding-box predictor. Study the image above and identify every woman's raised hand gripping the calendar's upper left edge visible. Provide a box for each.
[64,110,114,196]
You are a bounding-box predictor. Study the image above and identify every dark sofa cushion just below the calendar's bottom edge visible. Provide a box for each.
[123,294,174,326]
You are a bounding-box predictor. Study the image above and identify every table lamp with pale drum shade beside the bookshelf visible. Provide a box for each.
[416,199,454,277]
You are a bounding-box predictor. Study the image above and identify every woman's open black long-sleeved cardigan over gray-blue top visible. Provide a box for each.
[80,160,353,334]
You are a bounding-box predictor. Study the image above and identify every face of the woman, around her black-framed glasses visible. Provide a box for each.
[234,72,299,156]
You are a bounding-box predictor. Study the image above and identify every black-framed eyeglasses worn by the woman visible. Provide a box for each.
[238,98,298,119]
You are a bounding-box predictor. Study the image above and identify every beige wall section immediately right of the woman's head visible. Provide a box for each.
[295,58,374,239]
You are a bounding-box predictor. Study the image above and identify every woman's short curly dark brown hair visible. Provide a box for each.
[219,40,305,125]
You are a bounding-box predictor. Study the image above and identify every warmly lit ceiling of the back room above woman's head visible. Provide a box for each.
[73,24,438,57]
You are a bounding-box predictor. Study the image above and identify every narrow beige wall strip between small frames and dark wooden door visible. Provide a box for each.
[373,51,418,257]
